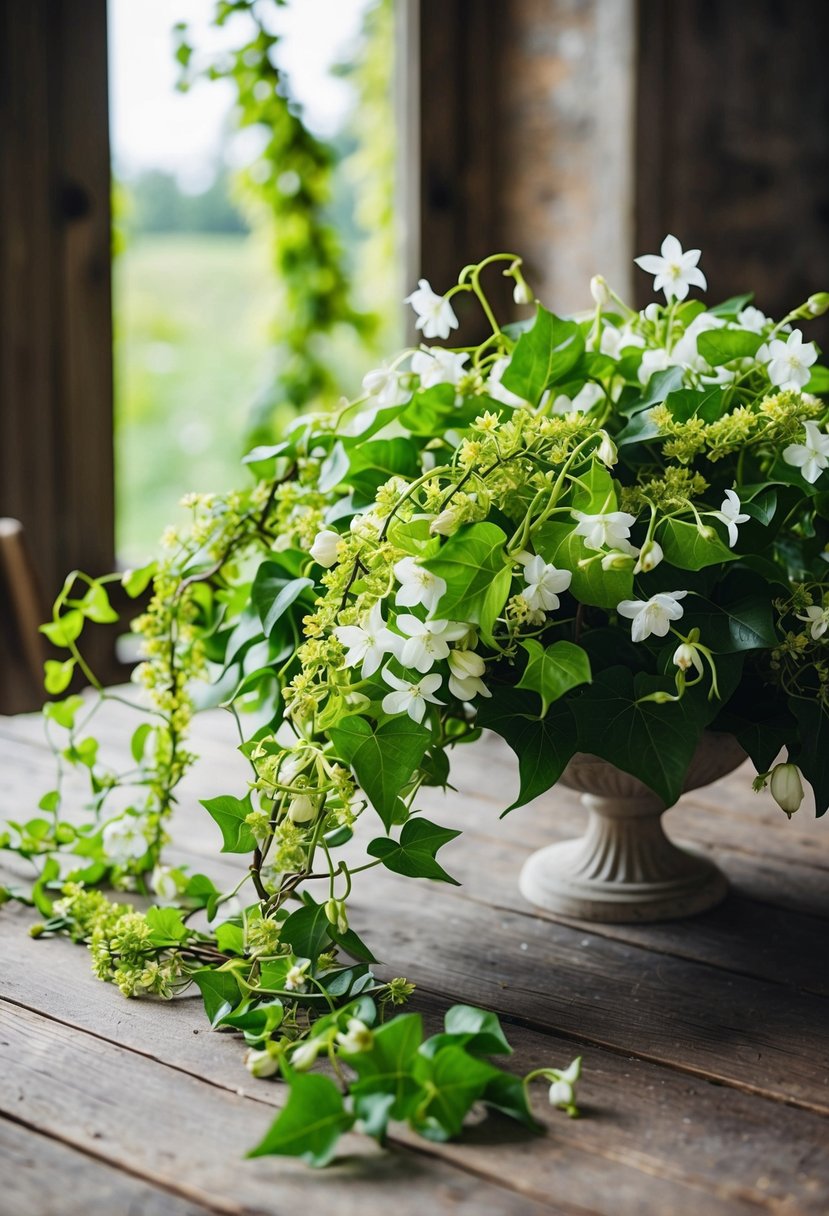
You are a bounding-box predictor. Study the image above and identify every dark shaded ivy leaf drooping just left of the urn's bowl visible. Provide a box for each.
[478,686,580,815]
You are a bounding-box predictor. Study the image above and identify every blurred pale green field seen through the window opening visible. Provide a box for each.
[113,233,275,564]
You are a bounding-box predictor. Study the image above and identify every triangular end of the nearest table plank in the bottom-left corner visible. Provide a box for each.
[0,1118,215,1216]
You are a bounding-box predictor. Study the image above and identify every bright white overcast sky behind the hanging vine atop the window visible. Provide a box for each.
[109,0,367,190]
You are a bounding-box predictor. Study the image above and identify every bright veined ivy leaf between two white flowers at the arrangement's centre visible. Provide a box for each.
[422,523,512,637]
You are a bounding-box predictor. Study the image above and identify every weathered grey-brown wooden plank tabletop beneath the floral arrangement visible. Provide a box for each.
[0,706,829,1216]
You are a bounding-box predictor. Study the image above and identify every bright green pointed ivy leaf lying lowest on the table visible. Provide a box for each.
[247,1066,354,1166]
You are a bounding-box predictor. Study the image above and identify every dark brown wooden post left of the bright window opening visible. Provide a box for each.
[0,0,115,711]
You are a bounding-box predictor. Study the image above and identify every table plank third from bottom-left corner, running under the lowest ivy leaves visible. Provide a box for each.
[0,913,829,1216]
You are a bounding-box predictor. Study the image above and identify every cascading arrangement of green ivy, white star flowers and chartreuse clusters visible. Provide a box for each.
[6,237,829,1162]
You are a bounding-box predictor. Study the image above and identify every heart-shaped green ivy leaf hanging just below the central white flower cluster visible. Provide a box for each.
[329,715,430,832]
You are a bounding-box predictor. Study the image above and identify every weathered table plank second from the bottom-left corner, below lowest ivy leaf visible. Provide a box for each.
[0,1002,559,1216]
